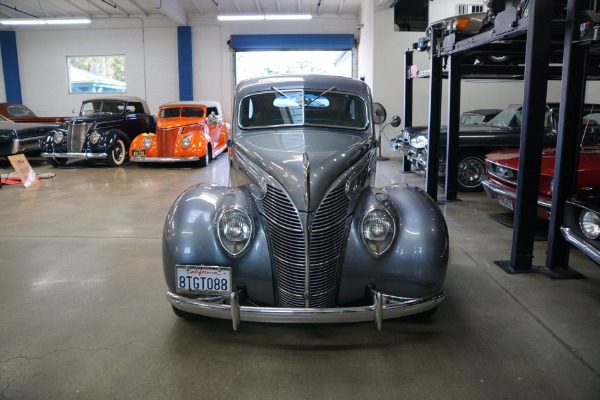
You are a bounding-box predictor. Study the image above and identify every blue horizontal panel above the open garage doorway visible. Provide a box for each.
[227,34,354,51]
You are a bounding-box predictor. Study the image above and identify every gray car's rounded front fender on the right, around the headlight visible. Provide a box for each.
[340,185,449,303]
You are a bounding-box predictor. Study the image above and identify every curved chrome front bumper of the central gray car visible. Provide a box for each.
[167,290,446,331]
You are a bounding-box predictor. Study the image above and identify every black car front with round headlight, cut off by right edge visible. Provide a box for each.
[560,188,600,264]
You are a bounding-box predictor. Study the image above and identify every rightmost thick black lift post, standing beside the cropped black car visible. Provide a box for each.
[546,0,588,278]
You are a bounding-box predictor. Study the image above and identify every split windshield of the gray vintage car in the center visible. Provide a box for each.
[238,88,369,129]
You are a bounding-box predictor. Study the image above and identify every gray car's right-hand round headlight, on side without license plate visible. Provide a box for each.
[360,208,396,257]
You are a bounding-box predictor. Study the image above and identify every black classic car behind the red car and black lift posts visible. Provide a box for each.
[402,103,600,192]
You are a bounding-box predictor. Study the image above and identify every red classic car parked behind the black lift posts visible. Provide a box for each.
[482,145,600,221]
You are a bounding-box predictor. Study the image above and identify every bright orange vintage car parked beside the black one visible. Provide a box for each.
[129,101,231,167]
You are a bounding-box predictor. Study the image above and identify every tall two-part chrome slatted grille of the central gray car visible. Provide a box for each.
[263,186,350,308]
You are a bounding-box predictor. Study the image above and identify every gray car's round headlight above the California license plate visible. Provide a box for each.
[217,209,252,257]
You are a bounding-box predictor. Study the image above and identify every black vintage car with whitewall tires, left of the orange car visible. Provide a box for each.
[42,96,156,167]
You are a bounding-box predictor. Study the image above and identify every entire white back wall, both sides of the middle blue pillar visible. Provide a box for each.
[2,15,358,119]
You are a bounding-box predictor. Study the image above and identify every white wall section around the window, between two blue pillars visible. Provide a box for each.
[9,18,179,116]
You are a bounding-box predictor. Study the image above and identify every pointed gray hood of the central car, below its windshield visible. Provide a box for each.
[235,129,373,211]
